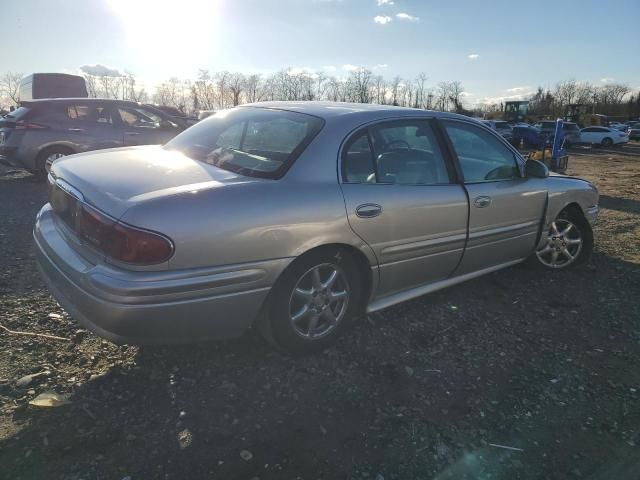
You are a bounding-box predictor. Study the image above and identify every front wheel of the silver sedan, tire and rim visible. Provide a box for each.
[536,212,593,270]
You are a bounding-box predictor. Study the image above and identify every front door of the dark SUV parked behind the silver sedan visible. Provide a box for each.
[118,105,182,145]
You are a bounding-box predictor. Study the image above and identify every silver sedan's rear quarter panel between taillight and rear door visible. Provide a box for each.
[121,179,375,269]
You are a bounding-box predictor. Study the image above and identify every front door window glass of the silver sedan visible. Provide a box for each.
[443,121,520,183]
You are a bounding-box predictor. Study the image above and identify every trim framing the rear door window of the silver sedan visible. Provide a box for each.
[337,115,460,187]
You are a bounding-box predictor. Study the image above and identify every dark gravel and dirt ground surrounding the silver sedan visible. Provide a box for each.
[0,144,640,480]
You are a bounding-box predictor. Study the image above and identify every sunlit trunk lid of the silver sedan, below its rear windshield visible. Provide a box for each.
[51,146,265,219]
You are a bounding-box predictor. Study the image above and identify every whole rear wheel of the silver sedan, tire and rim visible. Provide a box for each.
[261,250,363,354]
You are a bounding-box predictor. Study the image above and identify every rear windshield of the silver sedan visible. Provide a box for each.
[165,107,324,178]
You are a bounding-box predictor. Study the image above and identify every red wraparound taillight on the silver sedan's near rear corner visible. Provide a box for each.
[76,204,173,265]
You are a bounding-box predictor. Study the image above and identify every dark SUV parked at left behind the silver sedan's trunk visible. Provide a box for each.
[0,98,184,178]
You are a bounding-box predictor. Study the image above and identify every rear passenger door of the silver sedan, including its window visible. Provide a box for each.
[341,119,469,296]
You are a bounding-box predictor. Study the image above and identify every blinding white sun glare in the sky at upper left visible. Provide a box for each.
[109,0,218,77]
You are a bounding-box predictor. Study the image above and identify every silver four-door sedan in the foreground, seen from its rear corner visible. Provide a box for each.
[34,102,598,352]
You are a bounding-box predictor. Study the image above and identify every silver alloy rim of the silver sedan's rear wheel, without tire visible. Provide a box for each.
[289,263,350,340]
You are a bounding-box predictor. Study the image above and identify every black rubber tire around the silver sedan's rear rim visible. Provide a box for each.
[258,249,364,354]
